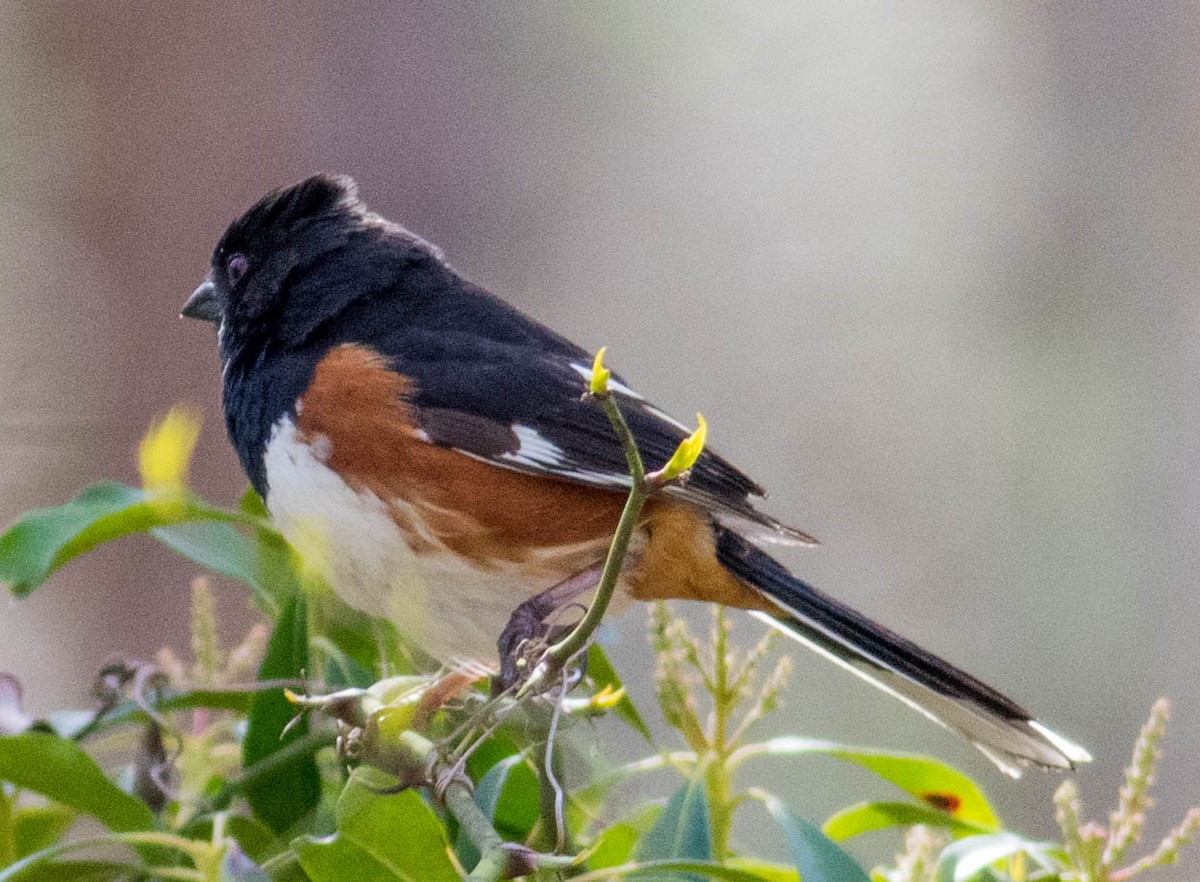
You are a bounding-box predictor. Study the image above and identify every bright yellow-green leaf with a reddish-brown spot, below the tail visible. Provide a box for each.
[739,736,1001,830]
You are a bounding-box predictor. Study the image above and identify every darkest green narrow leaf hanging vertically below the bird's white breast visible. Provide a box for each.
[241,592,320,833]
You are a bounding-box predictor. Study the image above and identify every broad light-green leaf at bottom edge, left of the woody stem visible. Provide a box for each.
[292,770,458,882]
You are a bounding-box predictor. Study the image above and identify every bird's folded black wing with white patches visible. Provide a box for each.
[367,286,814,544]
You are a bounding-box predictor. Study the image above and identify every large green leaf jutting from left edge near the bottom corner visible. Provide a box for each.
[0,732,154,832]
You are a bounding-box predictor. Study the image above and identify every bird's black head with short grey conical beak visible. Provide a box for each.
[182,175,436,361]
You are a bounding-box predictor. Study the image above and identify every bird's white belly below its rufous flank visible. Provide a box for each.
[264,418,604,664]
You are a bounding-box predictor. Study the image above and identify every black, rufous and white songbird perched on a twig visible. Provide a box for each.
[182,174,1091,776]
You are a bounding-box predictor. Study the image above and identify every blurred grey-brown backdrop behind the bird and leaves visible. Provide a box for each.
[0,0,1200,878]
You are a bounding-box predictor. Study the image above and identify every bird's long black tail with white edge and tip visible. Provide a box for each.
[716,527,1092,778]
